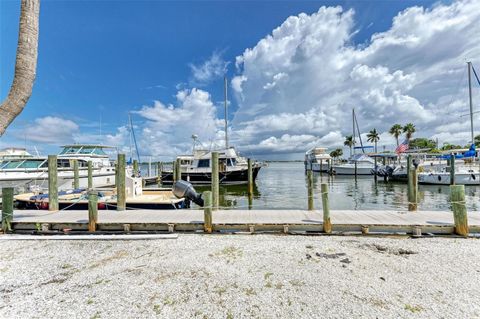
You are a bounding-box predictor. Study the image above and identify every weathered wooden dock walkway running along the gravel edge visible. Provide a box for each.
[12,209,480,234]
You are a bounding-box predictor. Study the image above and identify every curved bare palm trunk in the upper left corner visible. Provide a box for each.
[0,0,40,136]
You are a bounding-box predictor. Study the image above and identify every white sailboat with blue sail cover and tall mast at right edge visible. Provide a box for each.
[418,62,480,185]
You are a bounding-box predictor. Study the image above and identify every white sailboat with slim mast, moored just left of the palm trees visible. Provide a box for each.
[332,109,375,175]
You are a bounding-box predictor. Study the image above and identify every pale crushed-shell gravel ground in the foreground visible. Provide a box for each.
[0,234,480,318]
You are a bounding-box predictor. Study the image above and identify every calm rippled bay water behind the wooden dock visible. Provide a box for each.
[188,162,480,211]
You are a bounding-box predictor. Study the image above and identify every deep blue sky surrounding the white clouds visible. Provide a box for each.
[0,0,476,160]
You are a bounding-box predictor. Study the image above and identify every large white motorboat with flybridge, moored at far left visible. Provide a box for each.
[0,144,115,190]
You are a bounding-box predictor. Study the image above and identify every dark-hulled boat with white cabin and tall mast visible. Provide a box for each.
[162,76,262,184]
